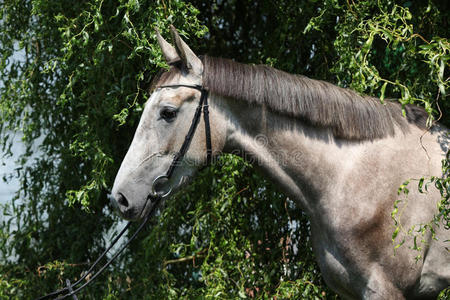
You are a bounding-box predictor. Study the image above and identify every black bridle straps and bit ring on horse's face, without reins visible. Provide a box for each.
[152,84,212,198]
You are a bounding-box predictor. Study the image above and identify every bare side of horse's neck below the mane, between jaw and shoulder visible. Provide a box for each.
[211,97,378,213]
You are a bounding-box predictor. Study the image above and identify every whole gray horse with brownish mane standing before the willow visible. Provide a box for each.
[112,27,450,299]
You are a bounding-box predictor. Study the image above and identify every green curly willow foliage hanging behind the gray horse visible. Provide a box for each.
[0,0,450,299]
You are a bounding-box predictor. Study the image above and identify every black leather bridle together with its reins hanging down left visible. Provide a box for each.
[36,84,212,300]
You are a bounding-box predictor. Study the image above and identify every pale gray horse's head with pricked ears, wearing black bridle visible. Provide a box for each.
[112,26,223,220]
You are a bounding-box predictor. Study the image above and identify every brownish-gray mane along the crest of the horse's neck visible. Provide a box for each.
[202,56,426,140]
